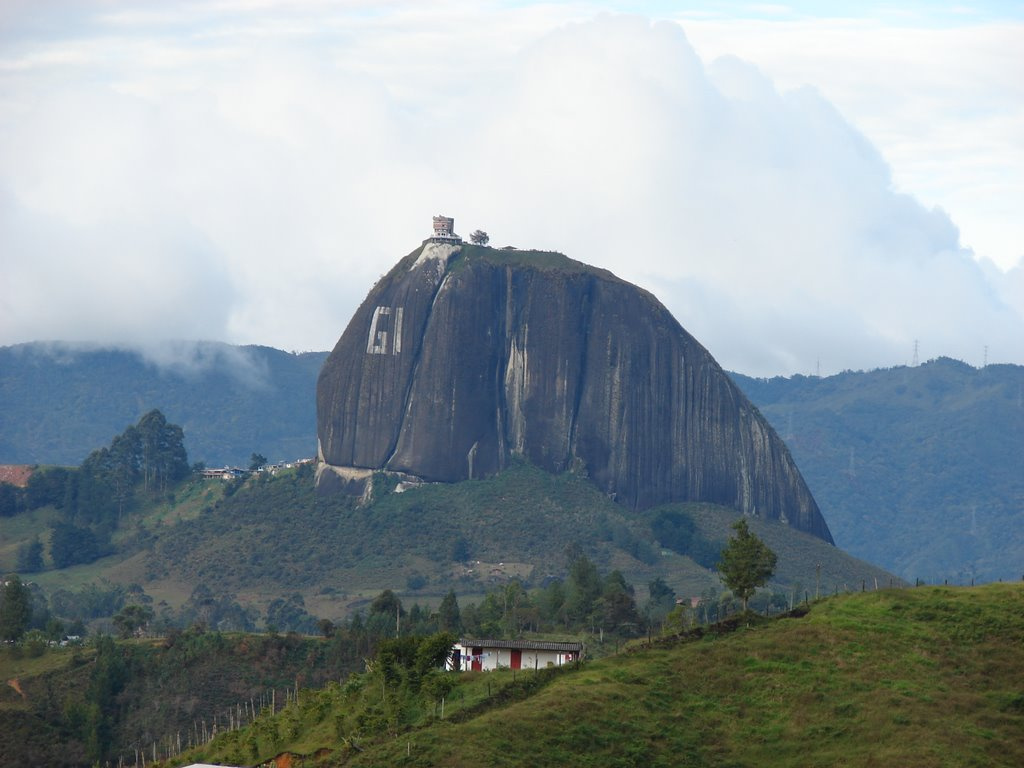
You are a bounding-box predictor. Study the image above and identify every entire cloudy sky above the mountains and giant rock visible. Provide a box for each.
[0,0,1024,376]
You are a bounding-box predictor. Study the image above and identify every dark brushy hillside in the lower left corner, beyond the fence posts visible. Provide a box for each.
[0,630,366,766]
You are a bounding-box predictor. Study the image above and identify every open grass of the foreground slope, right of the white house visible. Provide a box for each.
[362,585,1024,766]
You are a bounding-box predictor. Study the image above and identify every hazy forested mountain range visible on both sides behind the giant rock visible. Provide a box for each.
[0,344,1024,584]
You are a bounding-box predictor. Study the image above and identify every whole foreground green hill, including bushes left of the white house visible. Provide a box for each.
[171,584,1024,768]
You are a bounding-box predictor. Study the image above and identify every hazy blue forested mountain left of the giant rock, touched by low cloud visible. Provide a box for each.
[0,342,327,467]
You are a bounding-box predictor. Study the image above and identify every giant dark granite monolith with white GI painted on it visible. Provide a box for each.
[316,242,833,543]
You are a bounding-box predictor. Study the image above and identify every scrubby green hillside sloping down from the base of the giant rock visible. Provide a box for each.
[0,454,892,631]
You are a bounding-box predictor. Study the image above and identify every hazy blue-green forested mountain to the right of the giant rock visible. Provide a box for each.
[735,358,1024,584]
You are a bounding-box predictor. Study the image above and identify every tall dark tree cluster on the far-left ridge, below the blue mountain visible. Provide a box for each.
[0,410,189,573]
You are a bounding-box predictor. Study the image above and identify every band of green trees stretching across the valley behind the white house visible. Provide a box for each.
[0,551,782,657]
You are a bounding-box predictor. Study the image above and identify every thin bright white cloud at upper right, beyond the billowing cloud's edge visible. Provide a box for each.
[680,15,1024,269]
